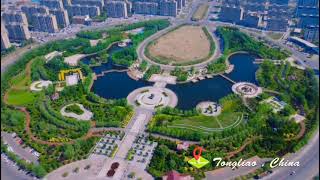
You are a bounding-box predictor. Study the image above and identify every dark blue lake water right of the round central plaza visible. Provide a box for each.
[167,54,258,109]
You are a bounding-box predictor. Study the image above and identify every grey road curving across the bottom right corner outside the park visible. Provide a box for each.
[263,131,319,180]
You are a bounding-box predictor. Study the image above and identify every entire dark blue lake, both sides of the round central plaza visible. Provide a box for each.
[92,51,258,109]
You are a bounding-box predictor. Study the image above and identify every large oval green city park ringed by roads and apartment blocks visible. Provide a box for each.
[1,17,319,179]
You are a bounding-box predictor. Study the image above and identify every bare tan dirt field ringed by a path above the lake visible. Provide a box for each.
[147,25,210,63]
